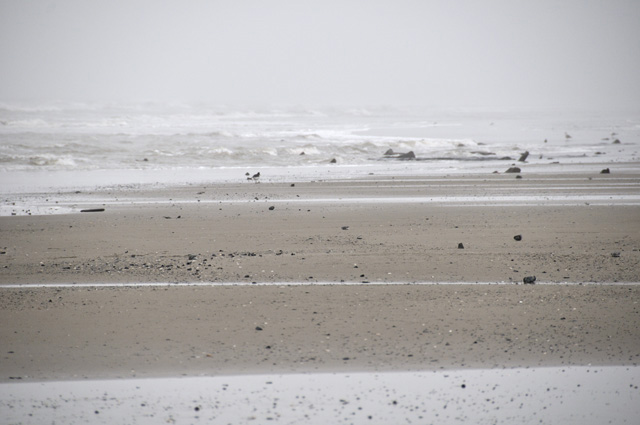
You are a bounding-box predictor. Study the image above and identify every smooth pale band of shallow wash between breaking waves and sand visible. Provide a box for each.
[0,161,640,197]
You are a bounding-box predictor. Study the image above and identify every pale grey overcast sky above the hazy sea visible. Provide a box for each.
[0,0,640,107]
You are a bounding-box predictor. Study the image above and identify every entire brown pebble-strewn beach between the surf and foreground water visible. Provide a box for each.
[0,175,640,381]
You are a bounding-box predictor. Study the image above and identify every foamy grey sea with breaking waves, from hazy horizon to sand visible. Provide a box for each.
[0,104,640,193]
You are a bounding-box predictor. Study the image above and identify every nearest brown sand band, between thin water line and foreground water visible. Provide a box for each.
[0,285,640,381]
